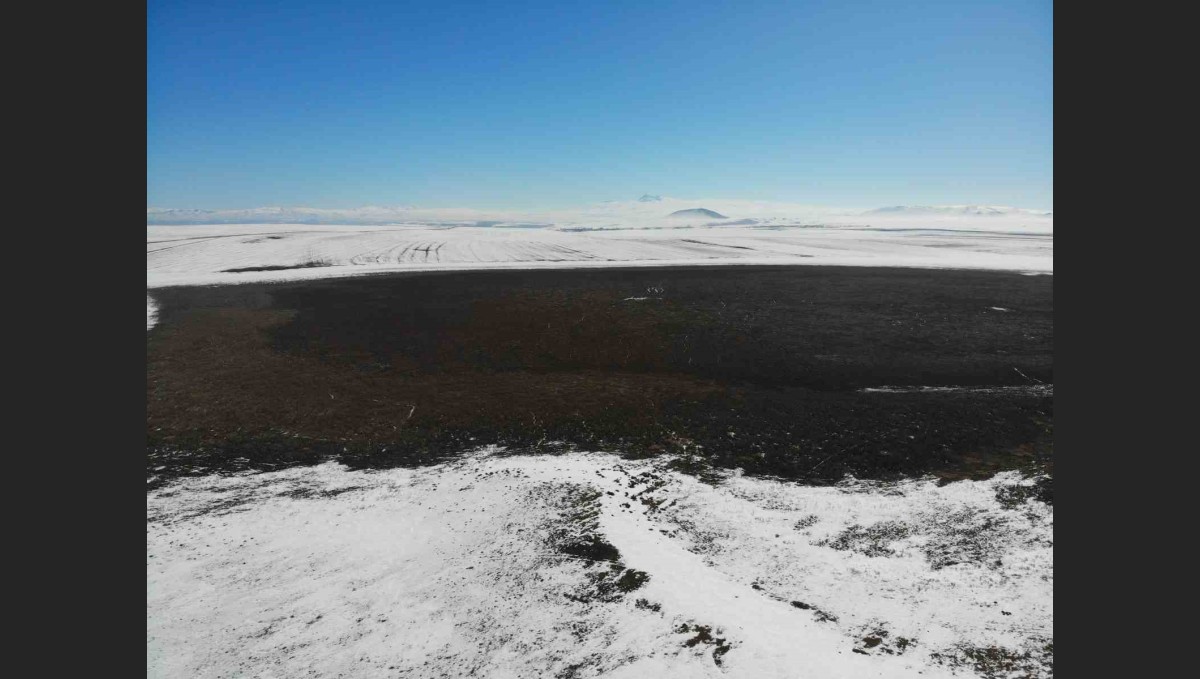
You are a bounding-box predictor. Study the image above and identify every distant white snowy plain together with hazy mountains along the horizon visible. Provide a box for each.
[146,199,1054,288]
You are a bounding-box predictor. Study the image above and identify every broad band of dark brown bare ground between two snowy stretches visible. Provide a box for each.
[146,266,1054,483]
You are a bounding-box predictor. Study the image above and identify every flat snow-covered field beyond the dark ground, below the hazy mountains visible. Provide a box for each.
[146,224,1054,288]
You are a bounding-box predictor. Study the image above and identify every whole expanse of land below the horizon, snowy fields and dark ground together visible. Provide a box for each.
[146,209,1054,679]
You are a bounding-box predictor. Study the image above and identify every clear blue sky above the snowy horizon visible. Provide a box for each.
[146,0,1054,209]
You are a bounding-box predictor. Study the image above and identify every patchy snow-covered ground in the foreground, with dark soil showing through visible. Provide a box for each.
[146,450,1054,678]
